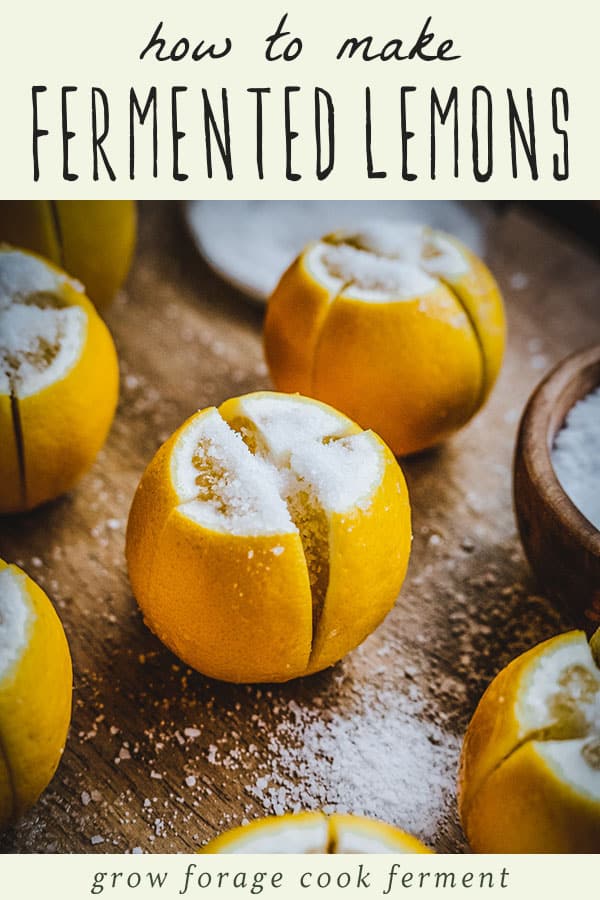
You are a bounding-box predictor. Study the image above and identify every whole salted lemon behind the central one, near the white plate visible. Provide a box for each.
[264,225,505,455]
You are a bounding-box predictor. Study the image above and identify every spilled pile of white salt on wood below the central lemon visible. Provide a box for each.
[218,683,460,843]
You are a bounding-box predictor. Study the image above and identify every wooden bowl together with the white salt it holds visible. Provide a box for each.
[513,344,600,634]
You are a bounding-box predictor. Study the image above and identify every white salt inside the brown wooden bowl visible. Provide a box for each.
[552,387,600,528]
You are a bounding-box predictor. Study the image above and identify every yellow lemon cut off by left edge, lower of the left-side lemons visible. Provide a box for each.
[0,560,72,827]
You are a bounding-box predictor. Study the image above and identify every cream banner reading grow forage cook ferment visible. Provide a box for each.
[1,854,599,900]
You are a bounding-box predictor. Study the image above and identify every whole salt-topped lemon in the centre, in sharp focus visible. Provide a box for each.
[127,392,411,682]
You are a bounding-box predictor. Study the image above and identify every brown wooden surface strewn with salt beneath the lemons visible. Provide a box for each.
[0,202,600,852]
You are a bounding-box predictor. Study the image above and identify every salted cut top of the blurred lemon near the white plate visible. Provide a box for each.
[306,222,469,303]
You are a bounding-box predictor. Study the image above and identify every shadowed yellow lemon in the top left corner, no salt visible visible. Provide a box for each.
[0,200,136,307]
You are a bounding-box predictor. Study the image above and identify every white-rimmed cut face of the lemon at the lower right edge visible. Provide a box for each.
[516,634,600,802]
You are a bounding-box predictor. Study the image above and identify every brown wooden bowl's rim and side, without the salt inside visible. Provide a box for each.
[513,345,600,633]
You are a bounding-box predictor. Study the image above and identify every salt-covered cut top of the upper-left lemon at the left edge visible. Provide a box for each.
[0,251,87,399]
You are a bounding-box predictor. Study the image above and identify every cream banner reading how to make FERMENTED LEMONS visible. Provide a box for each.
[0,0,600,199]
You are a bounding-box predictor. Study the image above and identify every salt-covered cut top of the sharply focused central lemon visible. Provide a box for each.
[171,393,384,536]
